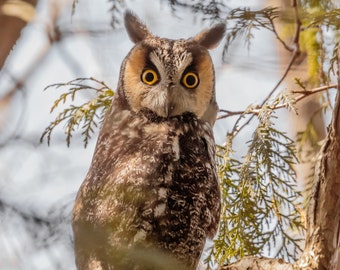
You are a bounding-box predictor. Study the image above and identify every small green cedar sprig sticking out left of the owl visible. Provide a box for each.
[40,78,113,147]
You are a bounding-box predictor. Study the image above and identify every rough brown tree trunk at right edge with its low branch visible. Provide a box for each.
[221,41,340,270]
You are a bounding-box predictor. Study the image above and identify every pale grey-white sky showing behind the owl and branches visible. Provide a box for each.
[0,0,290,270]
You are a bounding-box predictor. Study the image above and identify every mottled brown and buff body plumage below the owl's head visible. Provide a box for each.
[74,103,220,265]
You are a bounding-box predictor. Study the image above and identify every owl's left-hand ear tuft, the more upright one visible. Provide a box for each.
[124,11,151,43]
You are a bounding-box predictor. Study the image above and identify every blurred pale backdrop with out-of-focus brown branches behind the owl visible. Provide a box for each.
[0,0,338,270]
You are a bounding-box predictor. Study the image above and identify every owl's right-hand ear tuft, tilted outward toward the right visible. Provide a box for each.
[193,23,226,50]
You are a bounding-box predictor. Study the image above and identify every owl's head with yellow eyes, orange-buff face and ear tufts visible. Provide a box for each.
[118,12,225,124]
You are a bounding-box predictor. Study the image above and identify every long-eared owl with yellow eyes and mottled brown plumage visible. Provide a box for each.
[72,12,225,270]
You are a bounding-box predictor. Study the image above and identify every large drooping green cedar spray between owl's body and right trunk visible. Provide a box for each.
[208,99,303,265]
